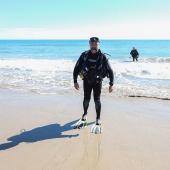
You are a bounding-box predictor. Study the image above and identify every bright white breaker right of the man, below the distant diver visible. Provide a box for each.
[111,60,170,80]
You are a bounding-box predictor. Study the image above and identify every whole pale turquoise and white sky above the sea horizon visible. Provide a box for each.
[0,0,170,39]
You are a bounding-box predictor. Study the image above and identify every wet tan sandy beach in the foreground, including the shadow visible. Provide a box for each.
[0,89,170,170]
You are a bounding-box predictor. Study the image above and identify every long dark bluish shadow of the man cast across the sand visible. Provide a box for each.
[0,120,93,150]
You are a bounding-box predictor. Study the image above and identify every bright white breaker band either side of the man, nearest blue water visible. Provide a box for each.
[0,59,170,80]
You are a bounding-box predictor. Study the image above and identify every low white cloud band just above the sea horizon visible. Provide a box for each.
[0,20,170,39]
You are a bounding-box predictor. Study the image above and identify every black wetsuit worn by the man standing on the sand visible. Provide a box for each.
[73,50,114,119]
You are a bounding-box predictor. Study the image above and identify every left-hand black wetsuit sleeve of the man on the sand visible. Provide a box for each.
[73,54,83,83]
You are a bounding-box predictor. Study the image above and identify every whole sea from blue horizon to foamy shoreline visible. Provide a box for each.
[0,40,170,99]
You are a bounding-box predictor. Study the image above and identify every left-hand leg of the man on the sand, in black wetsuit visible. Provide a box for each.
[82,80,92,120]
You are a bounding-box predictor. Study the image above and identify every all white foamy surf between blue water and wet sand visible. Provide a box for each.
[0,59,170,99]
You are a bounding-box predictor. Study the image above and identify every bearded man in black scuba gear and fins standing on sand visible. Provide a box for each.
[73,37,114,133]
